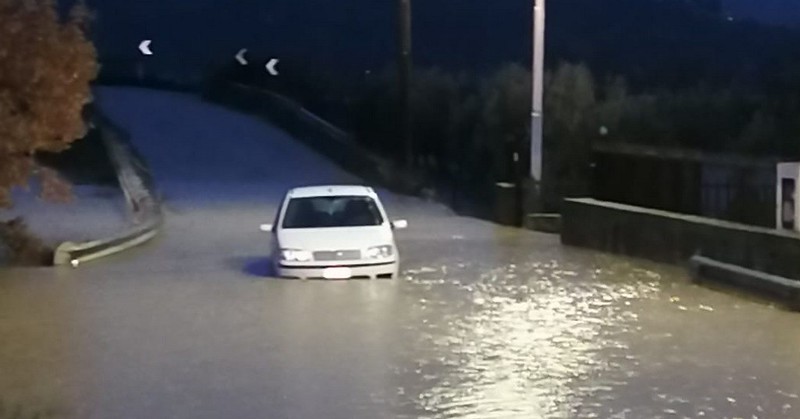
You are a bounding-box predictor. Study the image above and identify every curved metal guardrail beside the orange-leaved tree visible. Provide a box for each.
[53,111,163,267]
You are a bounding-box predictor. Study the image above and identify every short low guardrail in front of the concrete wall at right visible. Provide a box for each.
[689,255,800,311]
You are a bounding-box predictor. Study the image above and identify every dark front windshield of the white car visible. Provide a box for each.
[283,196,383,228]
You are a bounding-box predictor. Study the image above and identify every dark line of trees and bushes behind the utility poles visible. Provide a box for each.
[211,58,800,213]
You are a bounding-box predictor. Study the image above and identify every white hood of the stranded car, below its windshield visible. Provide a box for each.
[278,226,394,251]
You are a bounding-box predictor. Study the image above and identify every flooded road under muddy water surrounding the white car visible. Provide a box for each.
[0,89,800,419]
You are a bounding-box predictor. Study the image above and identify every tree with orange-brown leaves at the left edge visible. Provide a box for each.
[0,0,98,207]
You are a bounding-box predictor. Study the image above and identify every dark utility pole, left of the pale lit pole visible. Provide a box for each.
[397,0,414,168]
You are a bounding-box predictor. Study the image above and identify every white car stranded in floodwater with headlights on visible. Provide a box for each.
[261,185,408,279]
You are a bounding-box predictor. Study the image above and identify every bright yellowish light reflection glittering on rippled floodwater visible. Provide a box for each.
[400,251,659,419]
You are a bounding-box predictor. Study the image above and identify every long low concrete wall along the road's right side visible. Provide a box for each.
[561,198,800,279]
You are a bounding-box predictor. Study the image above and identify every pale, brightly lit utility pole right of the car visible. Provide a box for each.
[530,0,546,211]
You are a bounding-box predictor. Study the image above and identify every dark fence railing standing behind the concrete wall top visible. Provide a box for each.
[588,152,776,228]
